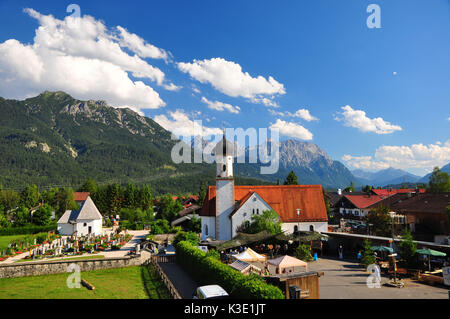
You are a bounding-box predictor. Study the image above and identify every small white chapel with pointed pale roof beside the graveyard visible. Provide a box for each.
[57,196,103,236]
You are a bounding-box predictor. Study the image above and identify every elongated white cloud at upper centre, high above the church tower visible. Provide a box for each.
[178,58,286,106]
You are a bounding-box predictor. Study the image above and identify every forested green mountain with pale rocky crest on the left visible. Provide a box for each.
[0,92,272,193]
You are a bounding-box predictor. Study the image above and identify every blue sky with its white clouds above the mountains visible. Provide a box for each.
[0,0,450,175]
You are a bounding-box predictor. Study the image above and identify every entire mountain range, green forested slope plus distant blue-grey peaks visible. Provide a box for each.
[0,92,442,193]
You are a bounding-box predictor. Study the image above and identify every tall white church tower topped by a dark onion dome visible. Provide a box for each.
[215,130,234,240]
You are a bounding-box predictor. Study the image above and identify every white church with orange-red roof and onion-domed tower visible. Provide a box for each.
[199,135,328,241]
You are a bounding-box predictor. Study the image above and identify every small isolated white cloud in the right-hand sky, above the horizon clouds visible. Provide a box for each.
[335,105,402,134]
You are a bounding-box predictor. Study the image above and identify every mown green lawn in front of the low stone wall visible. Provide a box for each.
[0,266,171,299]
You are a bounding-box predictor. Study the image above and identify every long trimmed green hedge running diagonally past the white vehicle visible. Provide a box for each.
[175,241,284,299]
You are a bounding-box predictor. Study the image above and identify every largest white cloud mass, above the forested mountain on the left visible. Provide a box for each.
[0,9,178,110]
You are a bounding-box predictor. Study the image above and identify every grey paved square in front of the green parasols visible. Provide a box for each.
[308,258,449,299]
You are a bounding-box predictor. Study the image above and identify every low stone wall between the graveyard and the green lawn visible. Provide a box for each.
[0,256,142,278]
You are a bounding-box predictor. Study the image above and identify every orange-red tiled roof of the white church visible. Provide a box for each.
[199,185,328,222]
